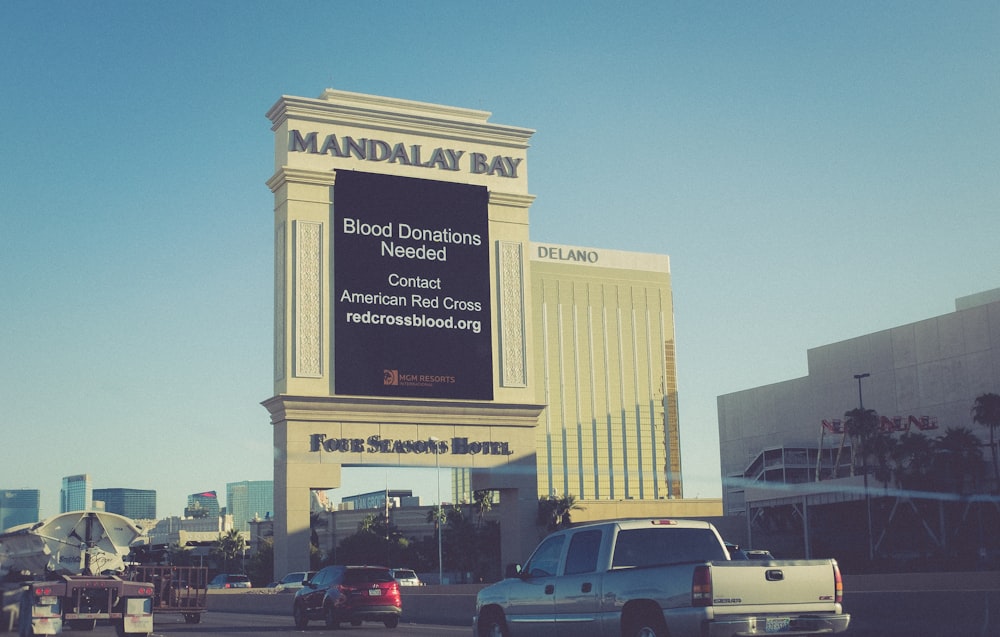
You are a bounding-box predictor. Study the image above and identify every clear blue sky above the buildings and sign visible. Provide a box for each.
[0,0,1000,516]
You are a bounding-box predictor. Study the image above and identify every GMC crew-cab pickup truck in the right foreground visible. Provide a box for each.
[473,519,850,637]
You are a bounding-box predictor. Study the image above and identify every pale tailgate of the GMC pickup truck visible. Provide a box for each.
[711,560,836,613]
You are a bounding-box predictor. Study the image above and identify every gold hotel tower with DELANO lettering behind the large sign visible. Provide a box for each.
[530,243,682,500]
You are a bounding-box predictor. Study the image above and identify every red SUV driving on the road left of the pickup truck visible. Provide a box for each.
[292,566,403,630]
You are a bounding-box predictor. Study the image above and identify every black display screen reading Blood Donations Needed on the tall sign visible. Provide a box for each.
[332,171,493,400]
